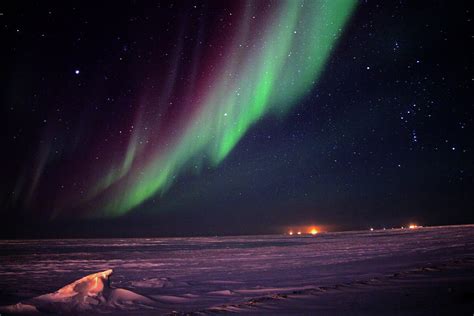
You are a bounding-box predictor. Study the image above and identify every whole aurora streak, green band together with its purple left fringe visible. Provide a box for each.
[6,0,355,216]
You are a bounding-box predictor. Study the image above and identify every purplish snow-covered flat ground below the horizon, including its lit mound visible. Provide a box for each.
[0,226,474,315]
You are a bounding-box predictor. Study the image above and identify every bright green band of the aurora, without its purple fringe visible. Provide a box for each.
[94,1,355,214]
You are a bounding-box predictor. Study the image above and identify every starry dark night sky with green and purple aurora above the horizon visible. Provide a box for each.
[0,0,474,237]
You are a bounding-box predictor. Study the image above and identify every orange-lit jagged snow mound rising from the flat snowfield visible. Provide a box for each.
[0,269,158,314]
